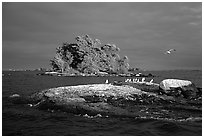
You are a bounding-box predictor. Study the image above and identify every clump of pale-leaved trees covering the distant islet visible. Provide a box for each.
[50,35,129,74]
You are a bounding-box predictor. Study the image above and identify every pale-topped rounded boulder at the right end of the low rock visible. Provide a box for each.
[159,79,198,98]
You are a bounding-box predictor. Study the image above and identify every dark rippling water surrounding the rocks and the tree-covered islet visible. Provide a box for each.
[2,71,202,136]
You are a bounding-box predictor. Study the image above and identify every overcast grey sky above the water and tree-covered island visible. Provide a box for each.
[2,2,202,70]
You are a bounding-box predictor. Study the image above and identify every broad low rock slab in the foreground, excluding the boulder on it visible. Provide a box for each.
[26,84,202,119]
